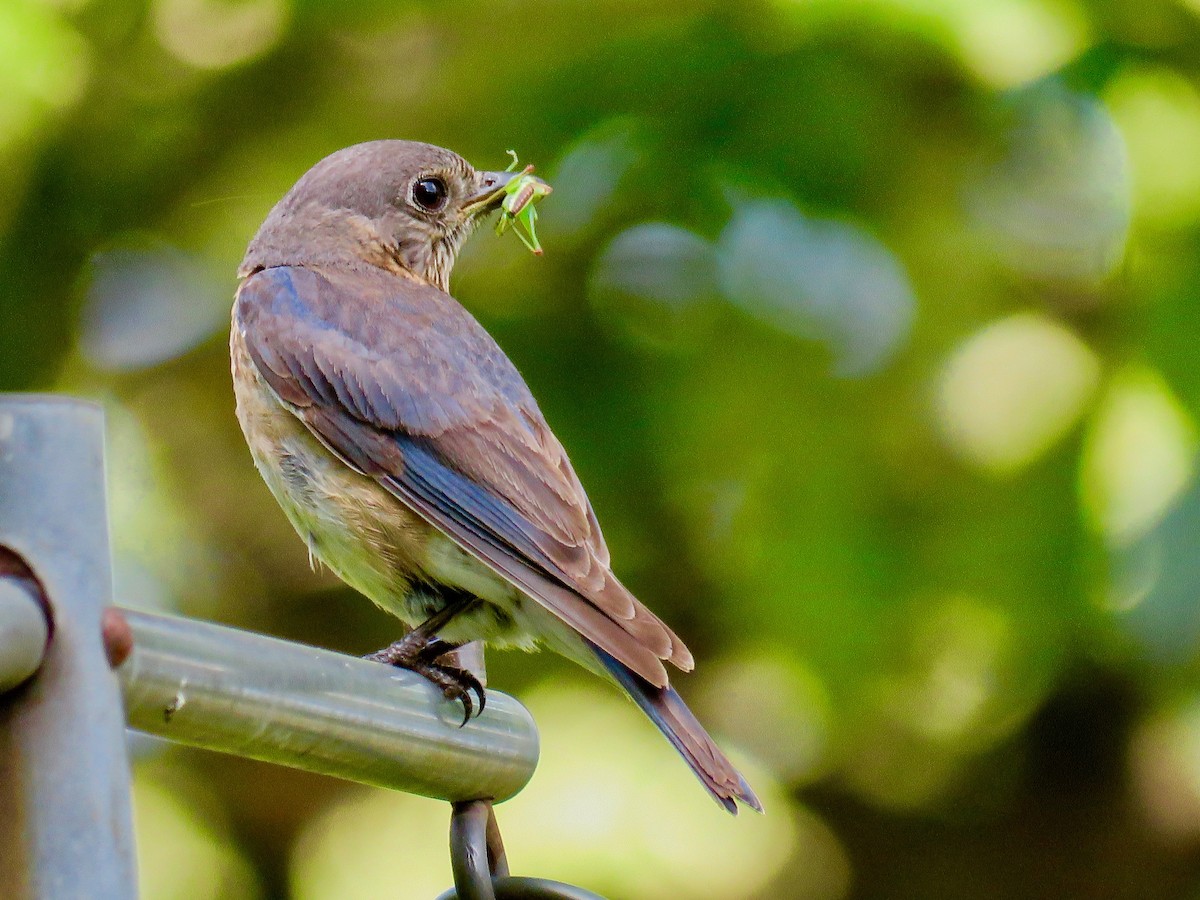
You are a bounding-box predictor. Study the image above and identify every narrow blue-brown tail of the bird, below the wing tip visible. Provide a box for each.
[592,644,762,815]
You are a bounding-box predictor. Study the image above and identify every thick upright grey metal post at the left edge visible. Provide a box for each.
[0,395,137,900]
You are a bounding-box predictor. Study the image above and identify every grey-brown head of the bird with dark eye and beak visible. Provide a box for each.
[239,140,525,290]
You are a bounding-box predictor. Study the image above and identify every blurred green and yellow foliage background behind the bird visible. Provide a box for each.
[0,0,1200,900]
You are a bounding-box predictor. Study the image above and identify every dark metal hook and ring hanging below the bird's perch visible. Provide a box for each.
[437,800,604,900]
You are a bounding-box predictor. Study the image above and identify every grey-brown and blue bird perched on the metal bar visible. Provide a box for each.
[230,139,762,814]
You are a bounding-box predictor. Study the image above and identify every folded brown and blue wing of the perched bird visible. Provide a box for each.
[235,266,691,686]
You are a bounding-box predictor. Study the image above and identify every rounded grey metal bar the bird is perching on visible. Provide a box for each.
[118,611,538,802]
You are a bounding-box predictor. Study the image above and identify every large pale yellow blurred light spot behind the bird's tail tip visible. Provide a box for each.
[506,683,799,900]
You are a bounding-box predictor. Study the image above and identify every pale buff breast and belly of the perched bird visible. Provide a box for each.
[229,316,536,647]
